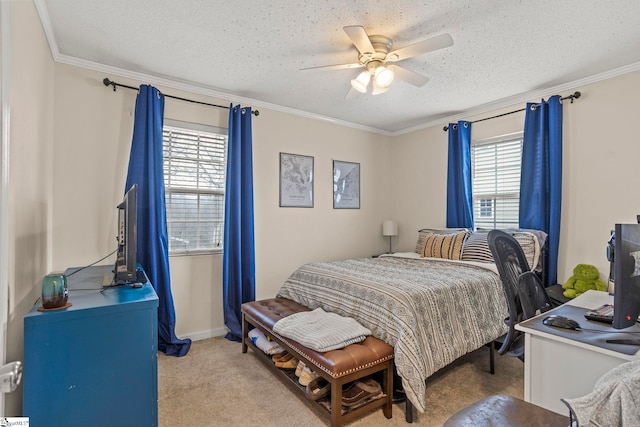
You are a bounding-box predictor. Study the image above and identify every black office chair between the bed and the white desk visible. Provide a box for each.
[487,230,553,360]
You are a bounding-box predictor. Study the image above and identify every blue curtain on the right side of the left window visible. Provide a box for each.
[222,105,256,341]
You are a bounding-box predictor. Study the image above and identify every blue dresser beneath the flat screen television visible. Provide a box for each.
[23,266,158,427]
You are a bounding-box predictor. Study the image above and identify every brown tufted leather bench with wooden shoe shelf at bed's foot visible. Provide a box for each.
[242,298,393,427]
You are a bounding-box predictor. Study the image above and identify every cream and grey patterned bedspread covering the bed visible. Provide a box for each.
[278,257,507,412]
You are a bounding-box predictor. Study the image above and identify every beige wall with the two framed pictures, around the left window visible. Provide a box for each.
[52,64,391,338]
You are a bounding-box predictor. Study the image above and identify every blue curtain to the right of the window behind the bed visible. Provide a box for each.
[520,95,562,286]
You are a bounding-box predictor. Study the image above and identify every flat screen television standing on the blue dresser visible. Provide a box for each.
[114,184,138,285]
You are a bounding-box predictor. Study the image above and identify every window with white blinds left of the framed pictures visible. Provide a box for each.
[162,120,227,254]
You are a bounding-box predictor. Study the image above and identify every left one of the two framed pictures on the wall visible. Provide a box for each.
[280,153,313,208]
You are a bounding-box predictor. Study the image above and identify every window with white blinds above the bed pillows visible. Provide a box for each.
[471,133,522,228]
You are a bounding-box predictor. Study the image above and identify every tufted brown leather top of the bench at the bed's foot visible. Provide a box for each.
[242,298,393,378]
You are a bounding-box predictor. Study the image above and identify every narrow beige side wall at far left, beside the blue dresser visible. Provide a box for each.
[2,2,53,416]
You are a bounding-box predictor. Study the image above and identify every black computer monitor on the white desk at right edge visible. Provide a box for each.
[613,224,640,329]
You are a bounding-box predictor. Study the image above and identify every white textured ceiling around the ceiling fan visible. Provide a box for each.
[35,0,640,133]
